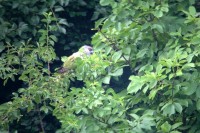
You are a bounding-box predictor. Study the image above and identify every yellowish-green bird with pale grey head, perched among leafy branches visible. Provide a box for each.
[58,45,93,73]
